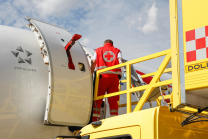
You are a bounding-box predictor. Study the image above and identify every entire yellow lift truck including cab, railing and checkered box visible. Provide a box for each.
[56,0,208,139]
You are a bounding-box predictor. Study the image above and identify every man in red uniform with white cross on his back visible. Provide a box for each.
[91,40,122,122]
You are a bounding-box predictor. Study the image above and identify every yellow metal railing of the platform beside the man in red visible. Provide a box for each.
[94,49,172,113]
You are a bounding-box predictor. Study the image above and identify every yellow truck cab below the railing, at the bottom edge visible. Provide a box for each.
[81,106,208,139]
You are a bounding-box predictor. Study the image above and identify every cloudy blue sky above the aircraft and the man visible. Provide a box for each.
[0,0,170,68]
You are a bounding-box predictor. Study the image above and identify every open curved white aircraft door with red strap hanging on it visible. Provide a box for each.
[27,18,93,126]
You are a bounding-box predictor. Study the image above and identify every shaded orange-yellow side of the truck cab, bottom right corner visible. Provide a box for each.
[157,107,208,139]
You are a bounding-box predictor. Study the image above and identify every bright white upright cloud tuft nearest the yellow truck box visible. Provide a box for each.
[139,3,158,33]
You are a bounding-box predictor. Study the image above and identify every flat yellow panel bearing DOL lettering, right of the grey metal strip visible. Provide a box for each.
[182,0,208,90]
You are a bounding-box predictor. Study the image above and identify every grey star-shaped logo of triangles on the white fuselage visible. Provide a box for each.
[11,46,32,64]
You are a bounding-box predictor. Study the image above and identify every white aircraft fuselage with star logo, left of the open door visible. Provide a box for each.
[0,26,70,139]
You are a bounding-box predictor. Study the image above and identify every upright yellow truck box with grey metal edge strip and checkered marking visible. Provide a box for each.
[170,0,208,108]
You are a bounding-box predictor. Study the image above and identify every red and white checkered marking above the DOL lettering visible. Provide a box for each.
[186,26,208,62]
